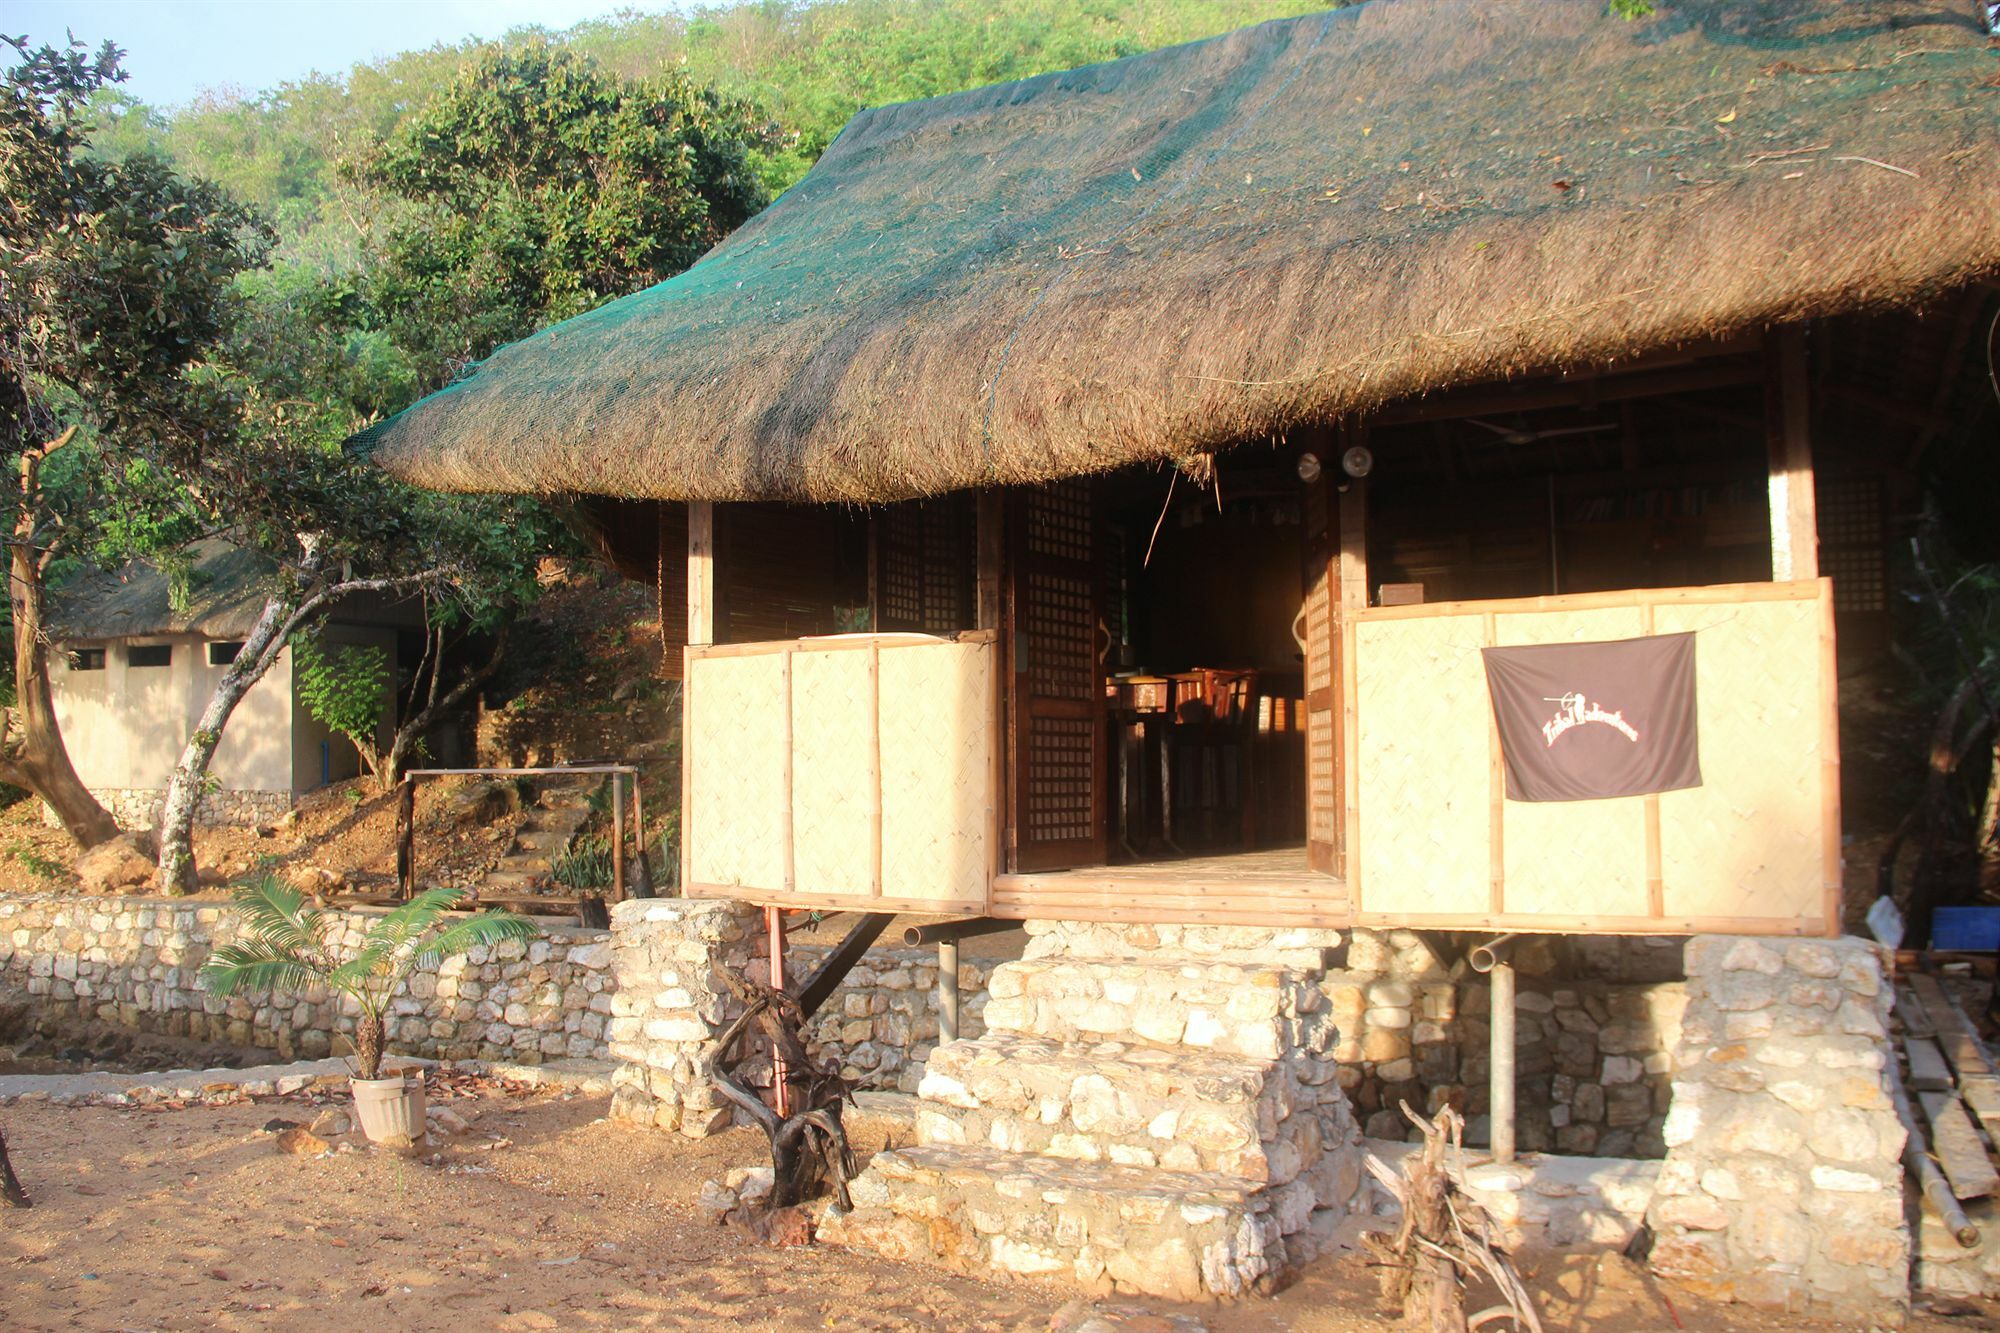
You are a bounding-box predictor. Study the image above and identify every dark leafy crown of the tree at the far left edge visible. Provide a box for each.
[0,29,272,576]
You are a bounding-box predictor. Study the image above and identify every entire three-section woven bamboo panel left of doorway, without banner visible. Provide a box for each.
[684,630,998,913]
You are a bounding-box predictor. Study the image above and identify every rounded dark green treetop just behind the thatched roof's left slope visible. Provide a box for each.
[348,40,774,386]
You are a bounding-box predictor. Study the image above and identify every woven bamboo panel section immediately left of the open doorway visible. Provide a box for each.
[884,642,996,907]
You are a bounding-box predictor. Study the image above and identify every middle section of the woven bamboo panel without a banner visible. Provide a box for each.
[788,648,876,897]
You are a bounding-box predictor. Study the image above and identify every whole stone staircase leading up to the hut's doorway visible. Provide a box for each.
[820,923,1362,1301]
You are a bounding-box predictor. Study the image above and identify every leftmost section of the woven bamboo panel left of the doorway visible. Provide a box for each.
[686,656,784,887]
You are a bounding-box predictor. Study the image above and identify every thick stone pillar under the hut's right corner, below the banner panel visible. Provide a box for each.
[1648,935,1910,1319]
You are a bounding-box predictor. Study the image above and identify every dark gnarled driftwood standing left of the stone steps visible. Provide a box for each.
[708,956,854,1239]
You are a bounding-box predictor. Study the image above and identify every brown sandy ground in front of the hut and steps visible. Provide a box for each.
[0,1087,1994,1333]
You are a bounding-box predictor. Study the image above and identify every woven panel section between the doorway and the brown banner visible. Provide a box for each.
[1354,614,1492,913]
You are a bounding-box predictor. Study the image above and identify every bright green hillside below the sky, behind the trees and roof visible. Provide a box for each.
[98,0,1328,268]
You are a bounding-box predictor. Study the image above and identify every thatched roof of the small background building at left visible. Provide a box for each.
[48,540,276,642]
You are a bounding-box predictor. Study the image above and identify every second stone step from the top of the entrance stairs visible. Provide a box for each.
[984,957,1332,1061]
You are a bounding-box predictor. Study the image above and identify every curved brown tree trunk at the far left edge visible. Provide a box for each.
[0,436,118,849]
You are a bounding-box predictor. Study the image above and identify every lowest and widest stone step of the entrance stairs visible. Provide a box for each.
[820,1145,1352,1301]
